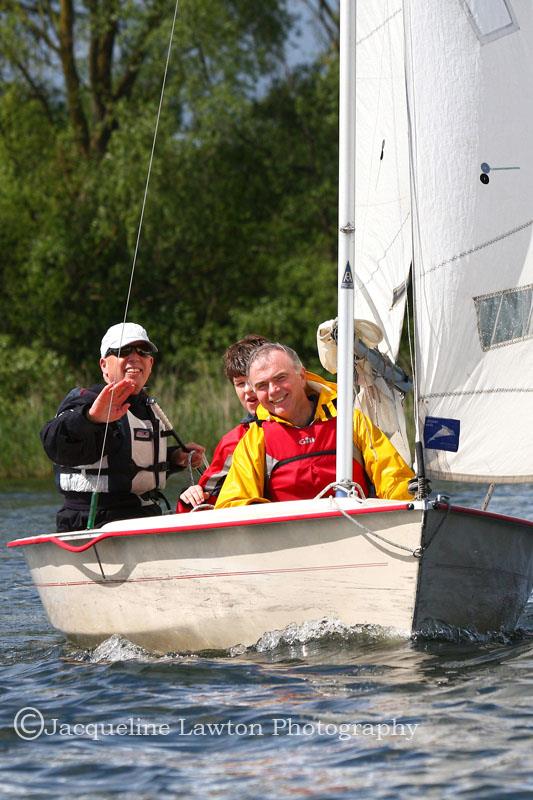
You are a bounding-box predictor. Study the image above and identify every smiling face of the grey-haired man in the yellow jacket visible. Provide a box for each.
[249,350,311,426]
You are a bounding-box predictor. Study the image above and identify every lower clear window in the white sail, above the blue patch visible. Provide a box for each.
[474,284,533,350]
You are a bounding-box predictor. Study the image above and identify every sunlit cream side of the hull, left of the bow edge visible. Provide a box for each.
[13,499,422,652]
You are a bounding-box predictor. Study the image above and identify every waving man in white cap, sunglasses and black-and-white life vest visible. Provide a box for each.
[41,322,205,531]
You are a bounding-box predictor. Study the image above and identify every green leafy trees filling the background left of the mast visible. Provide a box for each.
[0,0,344,473]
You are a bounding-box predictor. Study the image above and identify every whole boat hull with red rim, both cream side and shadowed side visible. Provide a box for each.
[11,498,533,652]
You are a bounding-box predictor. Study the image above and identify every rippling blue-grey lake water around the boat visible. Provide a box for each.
[0,486,533,800]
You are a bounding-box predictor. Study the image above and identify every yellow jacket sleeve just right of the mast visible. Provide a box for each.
[353,410,414,500]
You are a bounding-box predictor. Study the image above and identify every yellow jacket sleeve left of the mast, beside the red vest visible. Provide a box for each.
[215,424,270,508]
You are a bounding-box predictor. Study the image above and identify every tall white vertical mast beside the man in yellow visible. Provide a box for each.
[336,0,356,495]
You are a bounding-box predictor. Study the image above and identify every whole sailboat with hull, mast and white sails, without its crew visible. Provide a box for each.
[10,0,533,652]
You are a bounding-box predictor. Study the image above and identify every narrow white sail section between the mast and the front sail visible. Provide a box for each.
[355,0,411,361]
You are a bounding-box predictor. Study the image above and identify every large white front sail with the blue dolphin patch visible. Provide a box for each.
[404,0,533,482]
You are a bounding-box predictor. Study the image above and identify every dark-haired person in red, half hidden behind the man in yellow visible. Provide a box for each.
[176,333,268,513]
